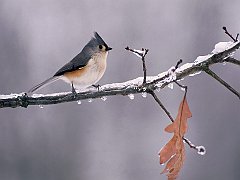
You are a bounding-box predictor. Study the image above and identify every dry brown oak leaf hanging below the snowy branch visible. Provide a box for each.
[159,94,192,180]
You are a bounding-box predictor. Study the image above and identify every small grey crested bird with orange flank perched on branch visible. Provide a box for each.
[28,32,112,93]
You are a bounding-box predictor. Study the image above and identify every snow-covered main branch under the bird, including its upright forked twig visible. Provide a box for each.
[0,38,240,108]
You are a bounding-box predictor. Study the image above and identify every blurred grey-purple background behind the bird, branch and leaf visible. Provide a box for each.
[0,0,240,180]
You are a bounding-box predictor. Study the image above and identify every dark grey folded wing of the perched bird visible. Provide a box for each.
[54,51,91,76]
